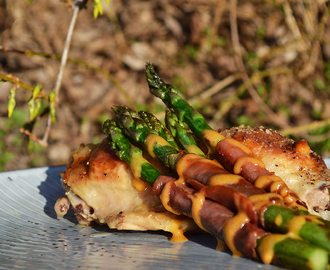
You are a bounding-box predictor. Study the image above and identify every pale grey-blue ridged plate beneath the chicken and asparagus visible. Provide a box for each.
[0,159,330,270]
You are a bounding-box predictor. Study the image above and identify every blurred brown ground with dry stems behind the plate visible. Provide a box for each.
[0,0,330,171]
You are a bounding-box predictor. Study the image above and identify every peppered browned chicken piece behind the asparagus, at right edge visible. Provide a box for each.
[218,126,330,220]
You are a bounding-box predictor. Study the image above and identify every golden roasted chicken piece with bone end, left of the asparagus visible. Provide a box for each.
[55,139,197,241]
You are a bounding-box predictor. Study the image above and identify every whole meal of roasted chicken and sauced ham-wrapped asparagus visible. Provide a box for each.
[55,64,330,270]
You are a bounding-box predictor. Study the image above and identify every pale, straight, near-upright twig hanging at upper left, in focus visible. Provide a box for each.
[42,0,88,146]
